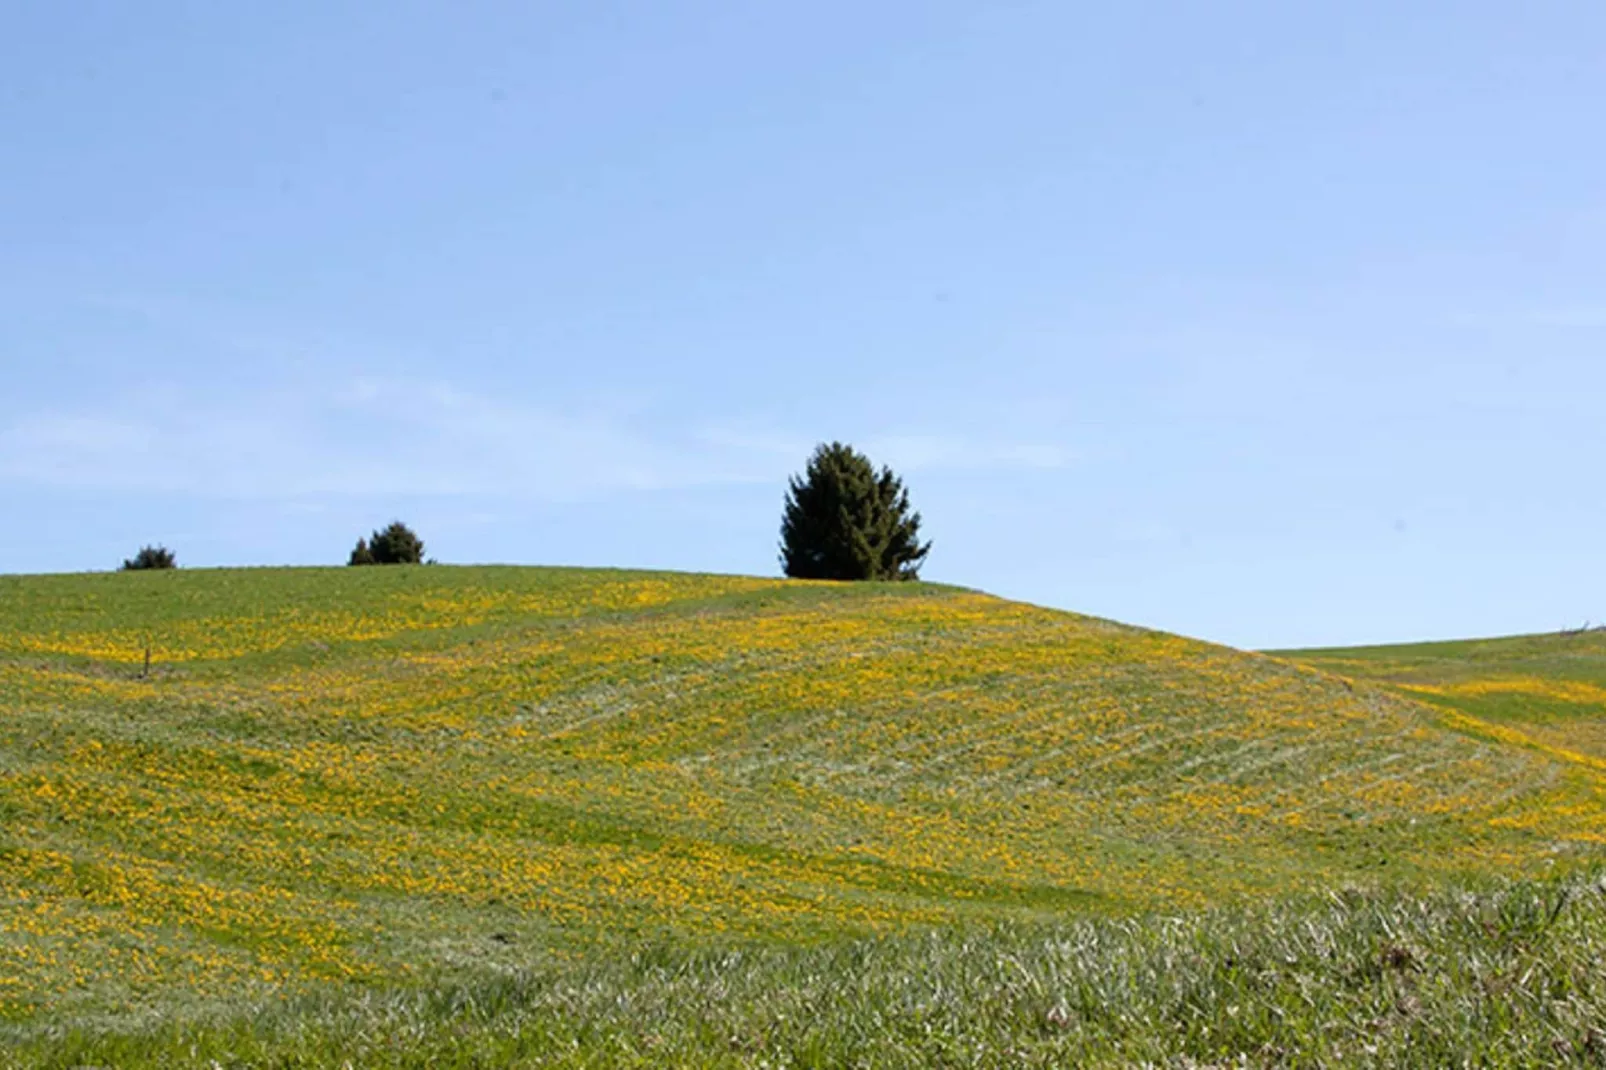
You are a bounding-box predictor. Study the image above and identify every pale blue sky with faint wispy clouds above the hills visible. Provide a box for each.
[0,0,1606,647]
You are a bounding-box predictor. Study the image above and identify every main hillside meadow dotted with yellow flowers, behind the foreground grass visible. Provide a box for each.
[0,569,1606,1017]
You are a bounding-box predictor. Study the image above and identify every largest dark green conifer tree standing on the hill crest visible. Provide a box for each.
[781,442,931,580]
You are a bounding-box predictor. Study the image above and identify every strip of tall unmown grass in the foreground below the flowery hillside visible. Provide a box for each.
[0,877,1606,1070]
